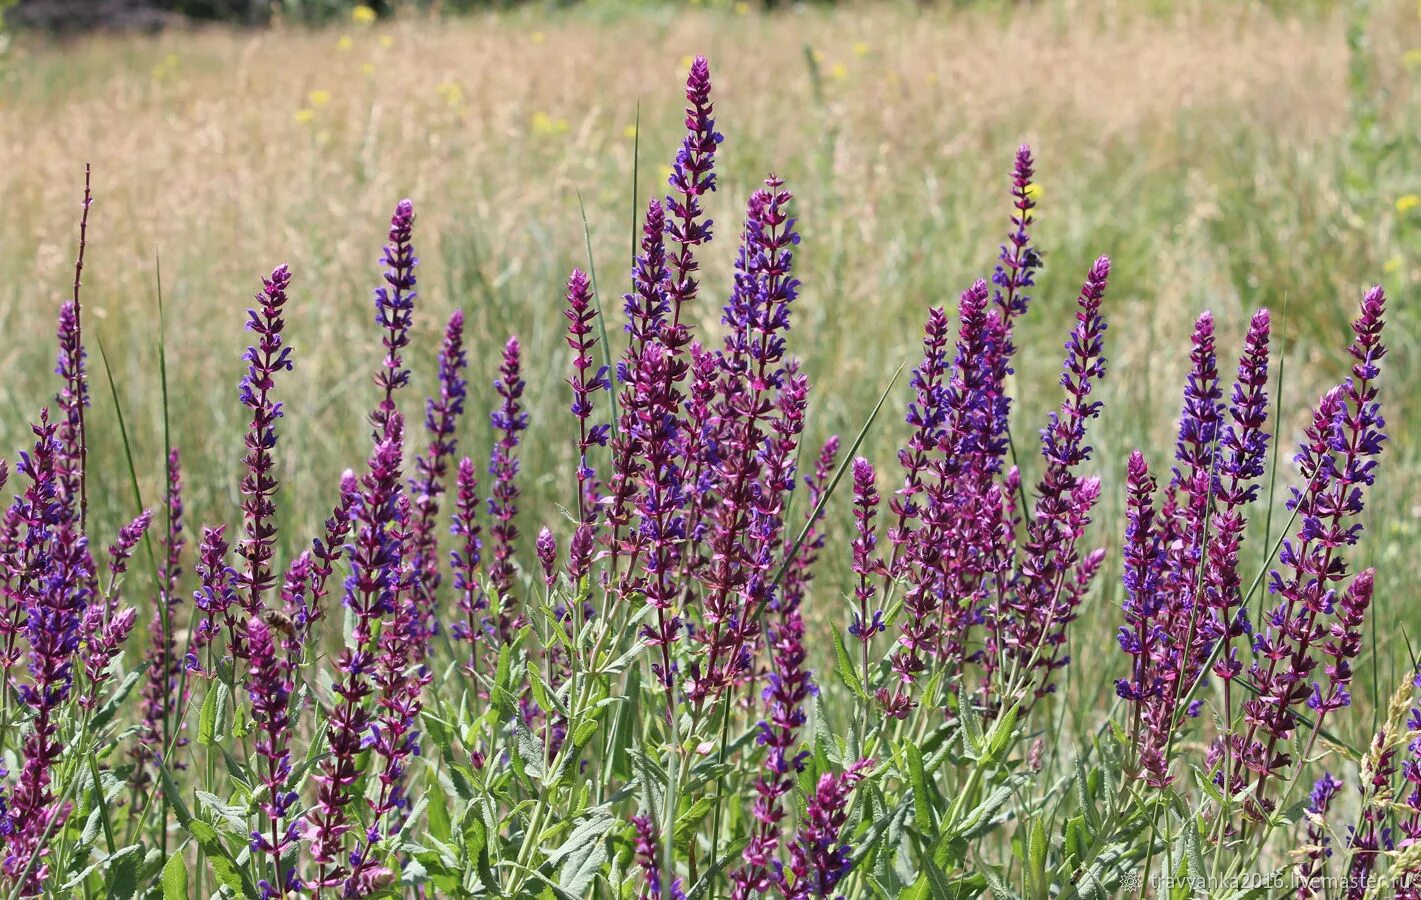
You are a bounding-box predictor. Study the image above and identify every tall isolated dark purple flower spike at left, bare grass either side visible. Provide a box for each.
[237,266,291,619]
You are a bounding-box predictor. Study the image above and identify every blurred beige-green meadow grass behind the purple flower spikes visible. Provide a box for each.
[0,0,1421,745]
